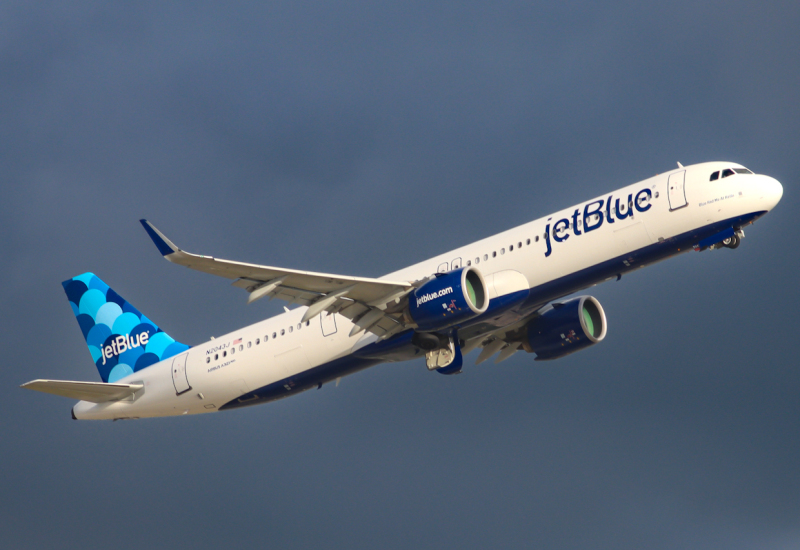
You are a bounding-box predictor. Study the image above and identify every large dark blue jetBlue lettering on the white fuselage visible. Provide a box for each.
[544,189,653,257]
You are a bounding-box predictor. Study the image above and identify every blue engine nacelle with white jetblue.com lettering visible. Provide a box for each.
[408,267,489,332]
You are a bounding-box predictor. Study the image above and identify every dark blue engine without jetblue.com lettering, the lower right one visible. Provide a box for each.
[523,296,607,361]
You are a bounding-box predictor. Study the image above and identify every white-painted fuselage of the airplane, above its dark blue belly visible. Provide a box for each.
[73,162,783,419]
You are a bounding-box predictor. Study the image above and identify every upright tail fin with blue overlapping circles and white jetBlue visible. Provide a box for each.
[61,273,189,382]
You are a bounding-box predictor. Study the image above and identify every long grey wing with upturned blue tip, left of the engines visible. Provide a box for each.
[140,220,416,338]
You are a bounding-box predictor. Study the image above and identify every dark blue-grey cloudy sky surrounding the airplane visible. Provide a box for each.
[0,0,800,550]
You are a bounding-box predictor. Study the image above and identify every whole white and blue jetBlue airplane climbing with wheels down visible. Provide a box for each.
[21,162,783,420]
